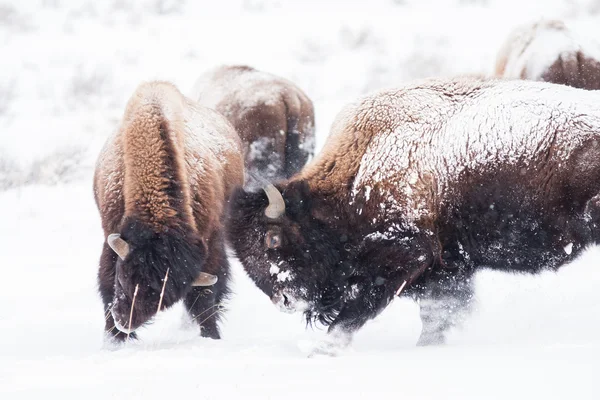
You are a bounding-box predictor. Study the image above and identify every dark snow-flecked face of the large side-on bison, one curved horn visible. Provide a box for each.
[228,181,343,313]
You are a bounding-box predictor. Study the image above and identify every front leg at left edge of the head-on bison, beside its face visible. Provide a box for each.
[98,242,136,343]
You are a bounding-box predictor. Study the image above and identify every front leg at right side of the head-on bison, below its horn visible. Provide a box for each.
[183,240,229,339]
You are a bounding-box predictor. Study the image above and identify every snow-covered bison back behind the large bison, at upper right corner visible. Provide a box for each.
[496,20,600,90]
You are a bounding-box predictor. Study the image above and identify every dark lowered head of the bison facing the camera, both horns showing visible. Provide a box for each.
[107,220,217,333]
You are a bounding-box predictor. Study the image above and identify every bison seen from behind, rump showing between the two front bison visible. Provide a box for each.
[192,65,315,185]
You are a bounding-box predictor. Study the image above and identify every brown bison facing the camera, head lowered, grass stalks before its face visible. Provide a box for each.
[94,82,243,341]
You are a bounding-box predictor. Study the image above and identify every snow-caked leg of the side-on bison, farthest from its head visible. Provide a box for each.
[417,275,473,346]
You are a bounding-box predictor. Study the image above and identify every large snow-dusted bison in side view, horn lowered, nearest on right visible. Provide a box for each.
[228,78,600,351]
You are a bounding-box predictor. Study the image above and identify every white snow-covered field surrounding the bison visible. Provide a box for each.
[0,0,600,399]
